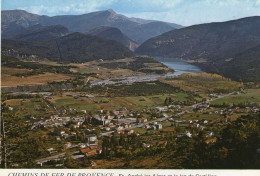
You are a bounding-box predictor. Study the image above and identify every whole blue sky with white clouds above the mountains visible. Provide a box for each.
[1,0,260,26]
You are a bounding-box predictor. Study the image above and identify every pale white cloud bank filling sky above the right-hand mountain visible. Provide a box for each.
[125,0,260,26]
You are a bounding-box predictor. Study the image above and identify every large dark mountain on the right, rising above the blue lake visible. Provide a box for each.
[136,16,260,80]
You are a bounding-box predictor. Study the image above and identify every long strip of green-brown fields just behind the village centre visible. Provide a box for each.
[51,93,192,112]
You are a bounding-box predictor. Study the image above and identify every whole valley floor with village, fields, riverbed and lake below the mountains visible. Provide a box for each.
[2,57,260,169]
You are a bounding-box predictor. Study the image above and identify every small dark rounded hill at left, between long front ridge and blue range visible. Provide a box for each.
[8,25,69,42]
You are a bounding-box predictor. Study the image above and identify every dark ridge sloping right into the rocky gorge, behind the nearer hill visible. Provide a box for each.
[85,26,138,51]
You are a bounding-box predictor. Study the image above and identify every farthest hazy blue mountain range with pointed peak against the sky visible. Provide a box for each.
[2,9,179,43]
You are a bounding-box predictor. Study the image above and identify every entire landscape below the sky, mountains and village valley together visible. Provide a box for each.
[1,9,260,169]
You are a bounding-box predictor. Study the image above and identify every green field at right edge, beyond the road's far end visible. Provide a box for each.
[211,89,260,105]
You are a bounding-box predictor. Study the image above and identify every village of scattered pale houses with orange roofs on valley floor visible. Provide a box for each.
[9,89,260,167]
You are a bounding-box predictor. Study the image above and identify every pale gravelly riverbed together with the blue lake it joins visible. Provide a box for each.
[91,58,202,86]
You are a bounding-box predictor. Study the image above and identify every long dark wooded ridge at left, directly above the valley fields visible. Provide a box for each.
[2,33,134,62]
